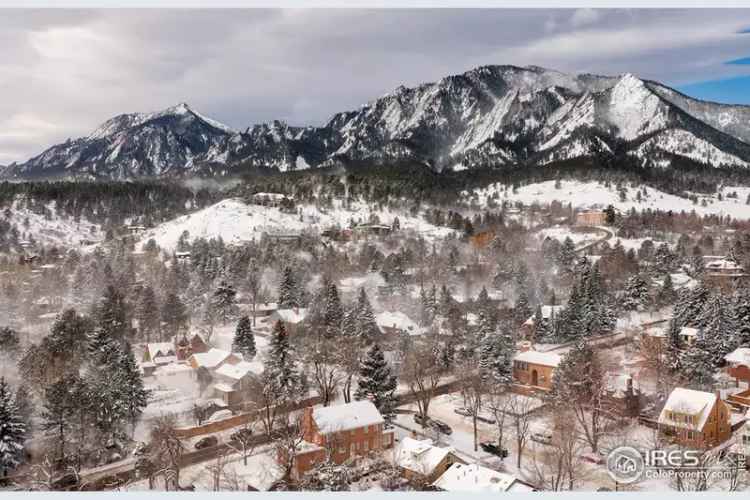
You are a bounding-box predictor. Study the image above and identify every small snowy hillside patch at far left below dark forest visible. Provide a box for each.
[0,201,104,247]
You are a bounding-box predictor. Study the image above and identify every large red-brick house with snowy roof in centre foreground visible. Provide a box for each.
[279,401,394,478]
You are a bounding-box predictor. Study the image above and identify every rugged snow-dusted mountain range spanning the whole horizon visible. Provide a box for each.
[0,66,750,179]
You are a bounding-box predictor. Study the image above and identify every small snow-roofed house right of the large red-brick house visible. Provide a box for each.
[395,437,466,484]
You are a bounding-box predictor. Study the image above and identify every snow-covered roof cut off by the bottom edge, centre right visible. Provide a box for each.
[432,463,536,493]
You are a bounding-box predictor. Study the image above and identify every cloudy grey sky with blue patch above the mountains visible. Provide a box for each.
[0,9,750,164]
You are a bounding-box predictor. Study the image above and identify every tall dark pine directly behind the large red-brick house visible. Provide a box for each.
[354,343,397,427]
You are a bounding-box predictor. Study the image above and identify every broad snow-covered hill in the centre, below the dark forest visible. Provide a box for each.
[135,198,452,251]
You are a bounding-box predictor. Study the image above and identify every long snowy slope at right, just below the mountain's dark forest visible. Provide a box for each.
[464,181,750,219]
